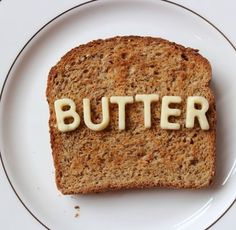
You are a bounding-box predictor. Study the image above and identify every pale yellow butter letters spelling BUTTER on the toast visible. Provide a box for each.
[54,94,209,132]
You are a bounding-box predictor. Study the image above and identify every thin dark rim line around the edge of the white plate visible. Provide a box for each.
[0,0,236,230]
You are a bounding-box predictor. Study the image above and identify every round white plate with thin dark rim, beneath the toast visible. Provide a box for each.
[0,0,236,230]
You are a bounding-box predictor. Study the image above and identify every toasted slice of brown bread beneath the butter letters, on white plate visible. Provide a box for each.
[46,36,216,194]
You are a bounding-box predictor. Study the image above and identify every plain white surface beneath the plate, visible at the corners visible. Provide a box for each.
[0,0,236,230]
